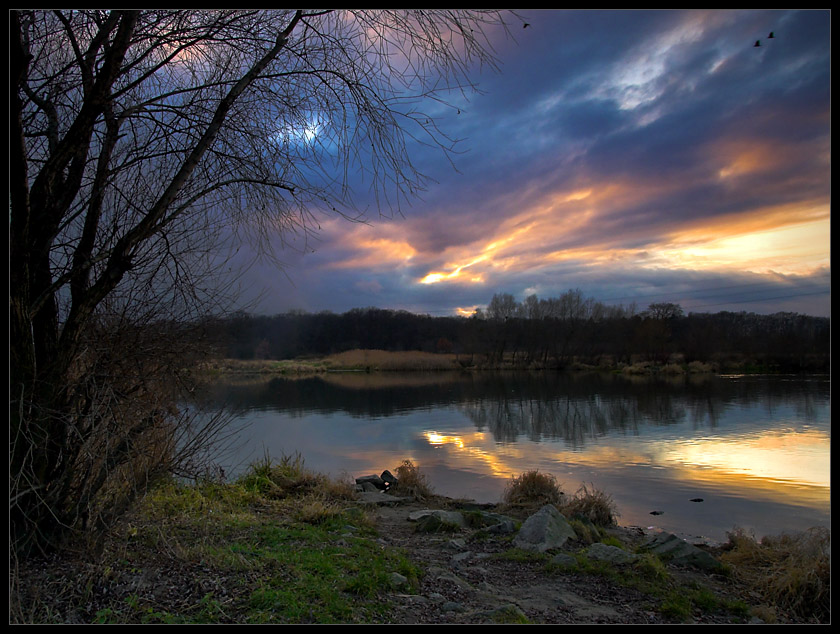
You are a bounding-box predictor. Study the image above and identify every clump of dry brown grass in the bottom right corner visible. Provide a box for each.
[721,528,831,623]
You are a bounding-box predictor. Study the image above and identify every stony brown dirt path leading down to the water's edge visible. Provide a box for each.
[370,494,752,623]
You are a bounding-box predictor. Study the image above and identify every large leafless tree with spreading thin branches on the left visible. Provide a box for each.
[9,10,504,542]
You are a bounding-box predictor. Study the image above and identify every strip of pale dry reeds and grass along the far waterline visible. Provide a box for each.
[198,349,804,377]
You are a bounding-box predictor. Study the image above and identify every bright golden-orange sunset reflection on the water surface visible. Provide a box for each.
[424,430,831,506]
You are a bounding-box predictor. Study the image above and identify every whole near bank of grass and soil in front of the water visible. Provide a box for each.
[10,455,830,624]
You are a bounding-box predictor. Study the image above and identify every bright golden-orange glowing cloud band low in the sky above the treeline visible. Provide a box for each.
[410,178,830,284]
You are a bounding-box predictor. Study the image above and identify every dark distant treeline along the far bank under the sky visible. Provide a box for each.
[200,290,831,372]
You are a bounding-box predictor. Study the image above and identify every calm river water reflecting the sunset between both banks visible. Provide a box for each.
[194,373,831,540]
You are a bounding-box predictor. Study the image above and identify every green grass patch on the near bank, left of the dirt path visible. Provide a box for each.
[80,456,420,623]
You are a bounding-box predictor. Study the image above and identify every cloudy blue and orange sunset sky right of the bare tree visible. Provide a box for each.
[238,10,831,316]
